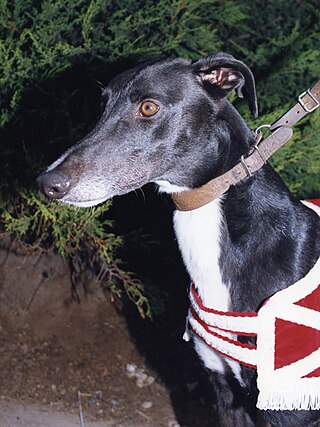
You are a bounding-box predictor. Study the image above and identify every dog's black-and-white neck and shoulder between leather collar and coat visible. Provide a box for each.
[174,165,319,311]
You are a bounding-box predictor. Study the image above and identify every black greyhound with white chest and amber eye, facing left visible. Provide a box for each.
[38,53,320,427]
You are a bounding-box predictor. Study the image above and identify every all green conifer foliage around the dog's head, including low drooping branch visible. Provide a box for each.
[0,0,320,314]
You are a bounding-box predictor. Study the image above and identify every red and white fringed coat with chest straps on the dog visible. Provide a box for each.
[184,258,320,410]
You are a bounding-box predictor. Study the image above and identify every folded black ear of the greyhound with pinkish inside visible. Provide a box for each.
[191,52,258,117]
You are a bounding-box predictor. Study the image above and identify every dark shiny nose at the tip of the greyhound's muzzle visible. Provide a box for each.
[37,171,71,199]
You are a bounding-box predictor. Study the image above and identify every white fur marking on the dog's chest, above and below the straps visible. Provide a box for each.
[174,199,242,383]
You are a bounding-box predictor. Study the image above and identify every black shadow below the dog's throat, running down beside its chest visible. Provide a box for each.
[110,186,215,427]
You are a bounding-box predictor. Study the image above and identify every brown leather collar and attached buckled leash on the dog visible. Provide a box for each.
[171,80,320,211]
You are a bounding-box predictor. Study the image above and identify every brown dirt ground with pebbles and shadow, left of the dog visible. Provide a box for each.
[0,242,218,427]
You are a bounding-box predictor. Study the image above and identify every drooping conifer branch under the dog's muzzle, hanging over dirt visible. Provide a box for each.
[0,192,152,317]
